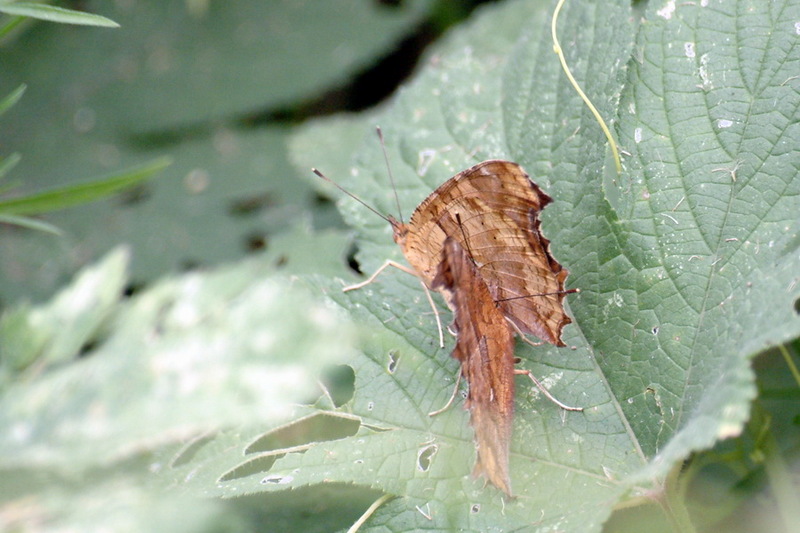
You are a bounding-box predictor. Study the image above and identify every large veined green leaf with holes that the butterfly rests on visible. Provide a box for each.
[153,0,800,531]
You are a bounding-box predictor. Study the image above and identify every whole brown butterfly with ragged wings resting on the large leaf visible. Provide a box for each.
[314,145,581,494]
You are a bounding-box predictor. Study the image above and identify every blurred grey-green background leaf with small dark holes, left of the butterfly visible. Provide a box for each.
[0,127,344,301]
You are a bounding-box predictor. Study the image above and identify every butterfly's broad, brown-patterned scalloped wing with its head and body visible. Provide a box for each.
[324,159,573,346]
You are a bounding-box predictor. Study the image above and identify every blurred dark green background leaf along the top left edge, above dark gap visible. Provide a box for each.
[0,0,431,132]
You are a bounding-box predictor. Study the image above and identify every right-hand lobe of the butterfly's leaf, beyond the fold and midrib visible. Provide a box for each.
[608,0,800,473]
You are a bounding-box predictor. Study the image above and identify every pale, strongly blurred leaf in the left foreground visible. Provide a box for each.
[0,246,355,468]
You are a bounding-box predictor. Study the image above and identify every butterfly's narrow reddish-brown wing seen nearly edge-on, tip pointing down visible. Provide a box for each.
[431,237,514,496]
